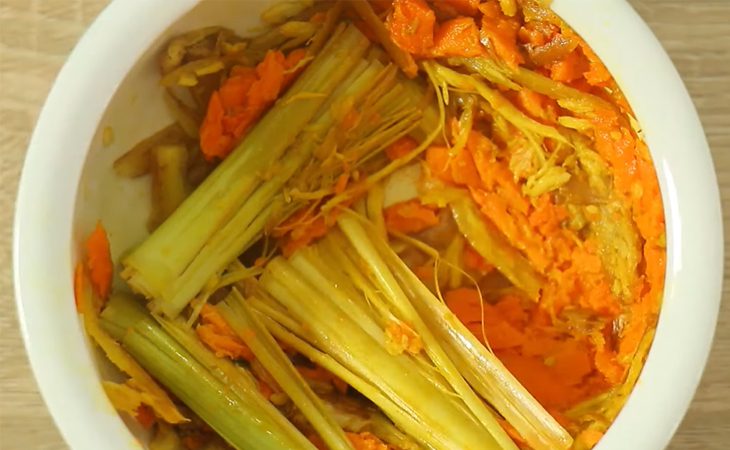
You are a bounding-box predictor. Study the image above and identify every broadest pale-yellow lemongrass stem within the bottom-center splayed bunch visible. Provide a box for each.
[261,260,504,449]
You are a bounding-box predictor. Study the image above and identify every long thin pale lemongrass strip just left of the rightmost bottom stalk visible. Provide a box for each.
[337,213,517,449]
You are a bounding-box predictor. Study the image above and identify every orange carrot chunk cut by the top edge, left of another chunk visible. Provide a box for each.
[385,0,436,56]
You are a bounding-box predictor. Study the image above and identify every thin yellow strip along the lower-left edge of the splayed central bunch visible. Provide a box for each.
[261,314,455,449]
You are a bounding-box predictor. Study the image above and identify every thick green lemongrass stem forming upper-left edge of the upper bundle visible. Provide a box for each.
[123,27,369,315]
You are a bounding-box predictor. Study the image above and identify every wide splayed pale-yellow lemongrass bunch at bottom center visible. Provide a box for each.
[262,218,515,449]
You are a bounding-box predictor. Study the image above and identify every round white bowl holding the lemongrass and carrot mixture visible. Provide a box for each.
[13,0,723,450]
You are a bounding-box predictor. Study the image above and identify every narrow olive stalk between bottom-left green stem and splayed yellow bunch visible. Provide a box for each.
[218,288,352,450]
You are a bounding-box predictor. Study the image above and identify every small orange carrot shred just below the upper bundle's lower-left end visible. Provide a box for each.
[195,304,254,361]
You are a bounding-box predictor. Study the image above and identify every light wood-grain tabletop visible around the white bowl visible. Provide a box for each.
[0,0,730,450]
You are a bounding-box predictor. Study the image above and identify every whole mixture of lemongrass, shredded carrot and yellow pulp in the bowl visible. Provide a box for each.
[74,0,666,450]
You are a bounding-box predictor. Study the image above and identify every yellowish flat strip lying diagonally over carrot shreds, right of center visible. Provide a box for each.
[450,195,543,300]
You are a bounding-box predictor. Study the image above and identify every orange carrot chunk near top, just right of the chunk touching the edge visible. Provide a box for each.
[431,17,484,58]
